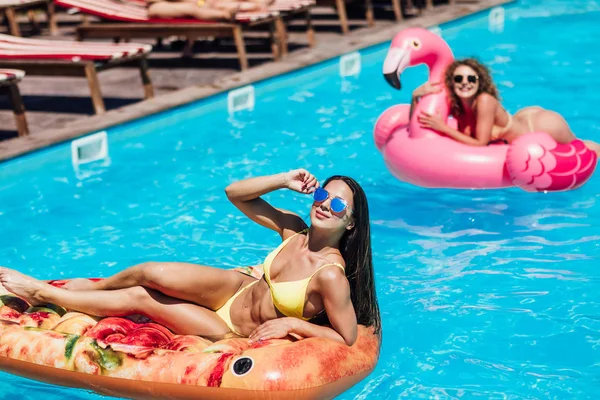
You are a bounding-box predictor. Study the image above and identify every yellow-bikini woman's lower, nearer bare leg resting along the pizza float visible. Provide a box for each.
[0,268,230,336]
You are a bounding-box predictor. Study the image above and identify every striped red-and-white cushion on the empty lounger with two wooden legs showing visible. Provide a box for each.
[0,34,152,62]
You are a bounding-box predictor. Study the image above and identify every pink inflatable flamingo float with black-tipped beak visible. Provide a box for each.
[374,28,597,191]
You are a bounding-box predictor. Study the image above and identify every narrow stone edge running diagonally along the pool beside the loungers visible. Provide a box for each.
[0,0,517,163]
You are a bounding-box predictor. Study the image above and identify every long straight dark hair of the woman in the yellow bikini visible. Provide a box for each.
[323,175,381,335]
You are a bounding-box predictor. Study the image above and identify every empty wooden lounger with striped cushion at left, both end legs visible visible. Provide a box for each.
[0,34,154,114]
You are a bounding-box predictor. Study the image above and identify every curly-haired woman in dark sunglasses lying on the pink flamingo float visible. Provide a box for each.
[413,58,600,155]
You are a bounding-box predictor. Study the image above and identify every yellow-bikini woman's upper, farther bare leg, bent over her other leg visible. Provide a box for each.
[66,262,254,310]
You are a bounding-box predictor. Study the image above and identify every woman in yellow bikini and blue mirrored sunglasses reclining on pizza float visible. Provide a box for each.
[0,169,380,345]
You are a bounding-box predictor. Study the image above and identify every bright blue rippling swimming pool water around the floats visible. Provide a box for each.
[0,0,600,399]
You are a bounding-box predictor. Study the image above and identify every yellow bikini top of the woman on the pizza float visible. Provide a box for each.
[263,229,344,321]
